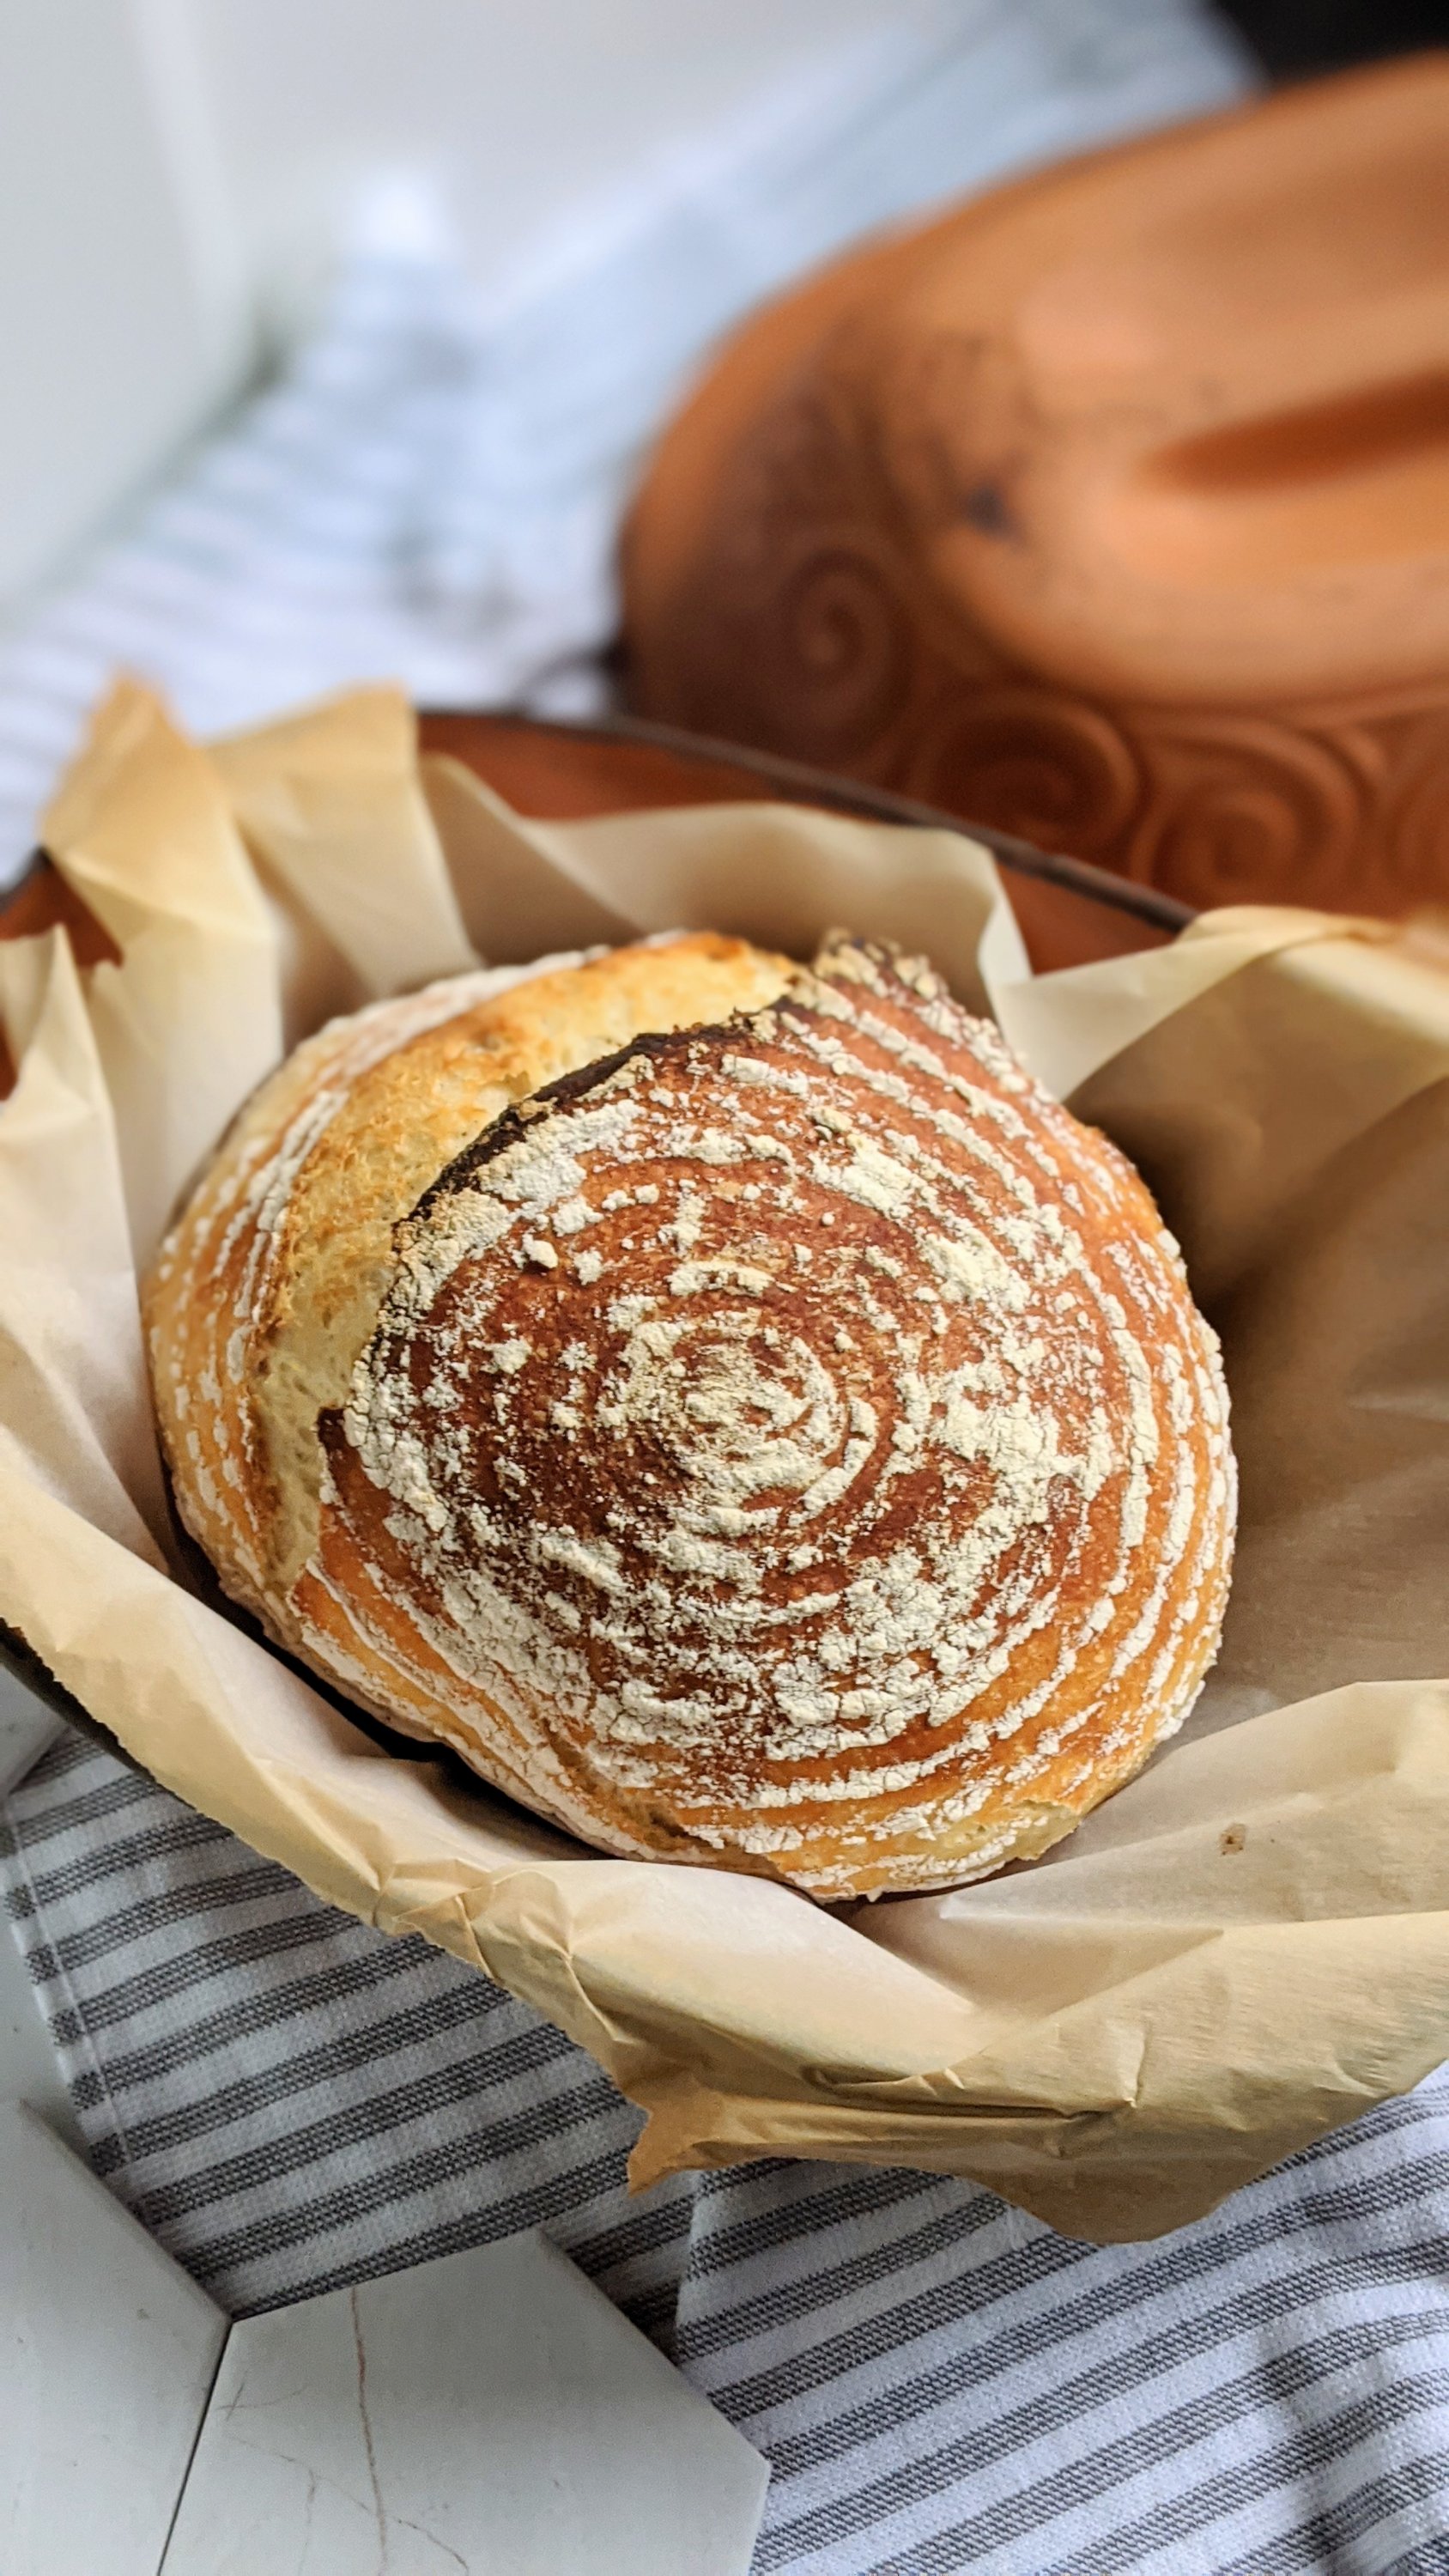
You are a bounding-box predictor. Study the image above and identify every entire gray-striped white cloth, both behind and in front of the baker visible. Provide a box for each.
[11,0,1449,2576]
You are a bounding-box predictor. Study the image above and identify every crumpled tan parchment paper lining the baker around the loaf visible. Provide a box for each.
[0,685,1449,2239]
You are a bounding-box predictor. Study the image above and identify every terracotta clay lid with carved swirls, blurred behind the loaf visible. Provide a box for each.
[626,54,1449,914]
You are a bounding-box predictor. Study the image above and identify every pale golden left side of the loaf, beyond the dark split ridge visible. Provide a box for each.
[144,933,790,1646]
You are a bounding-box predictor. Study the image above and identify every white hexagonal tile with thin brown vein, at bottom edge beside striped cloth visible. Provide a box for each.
[165,2236,767,2576]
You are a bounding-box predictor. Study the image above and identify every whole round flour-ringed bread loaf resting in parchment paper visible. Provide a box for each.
[147,935,1233,1899]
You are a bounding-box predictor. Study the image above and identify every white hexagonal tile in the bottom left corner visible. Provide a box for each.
[0,2105,227,2576]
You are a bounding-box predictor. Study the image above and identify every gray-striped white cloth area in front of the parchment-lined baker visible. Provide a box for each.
[0,1736,1449,2576]
